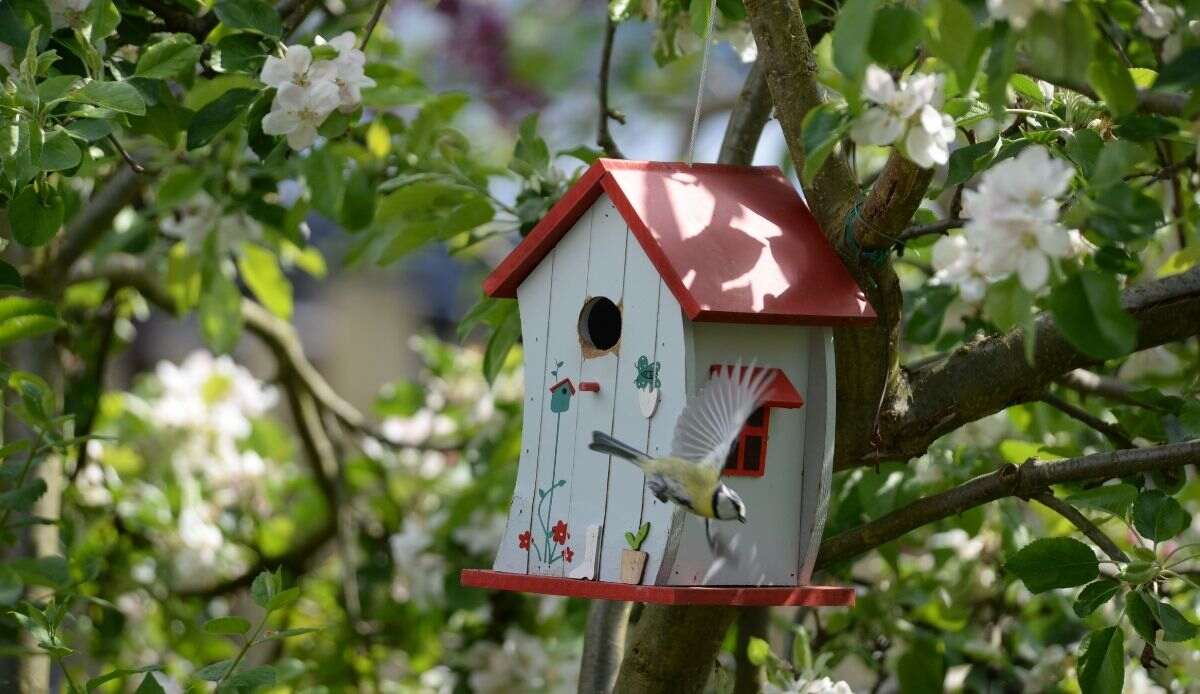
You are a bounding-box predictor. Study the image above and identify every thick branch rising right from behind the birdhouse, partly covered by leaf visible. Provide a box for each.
[864,268,1200,468]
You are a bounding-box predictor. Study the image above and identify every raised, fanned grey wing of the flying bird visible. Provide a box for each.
[671,361,774,469]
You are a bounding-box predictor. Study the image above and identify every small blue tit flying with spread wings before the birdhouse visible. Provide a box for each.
[588,364,773,551]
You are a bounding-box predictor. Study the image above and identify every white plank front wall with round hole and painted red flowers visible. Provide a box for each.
[494,196,685,582]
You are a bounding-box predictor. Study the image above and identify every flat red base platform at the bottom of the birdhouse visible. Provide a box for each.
[460,569,854,608]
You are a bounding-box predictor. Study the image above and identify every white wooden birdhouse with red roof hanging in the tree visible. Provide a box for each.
[462,160,875,605]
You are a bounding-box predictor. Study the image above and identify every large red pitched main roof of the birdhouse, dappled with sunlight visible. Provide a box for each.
[484,158,875,325]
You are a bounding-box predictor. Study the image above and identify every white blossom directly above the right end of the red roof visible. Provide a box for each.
[850,65,954,168]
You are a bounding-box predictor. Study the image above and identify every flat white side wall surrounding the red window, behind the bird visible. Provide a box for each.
[662,323,824,586]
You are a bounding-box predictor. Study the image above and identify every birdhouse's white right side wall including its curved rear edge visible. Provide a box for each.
[660,323,834,586]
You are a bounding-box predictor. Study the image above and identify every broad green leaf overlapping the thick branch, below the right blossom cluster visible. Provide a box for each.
[1050,270,1138,359]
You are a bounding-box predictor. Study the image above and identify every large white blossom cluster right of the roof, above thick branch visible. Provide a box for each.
[960,146,1082,292]
